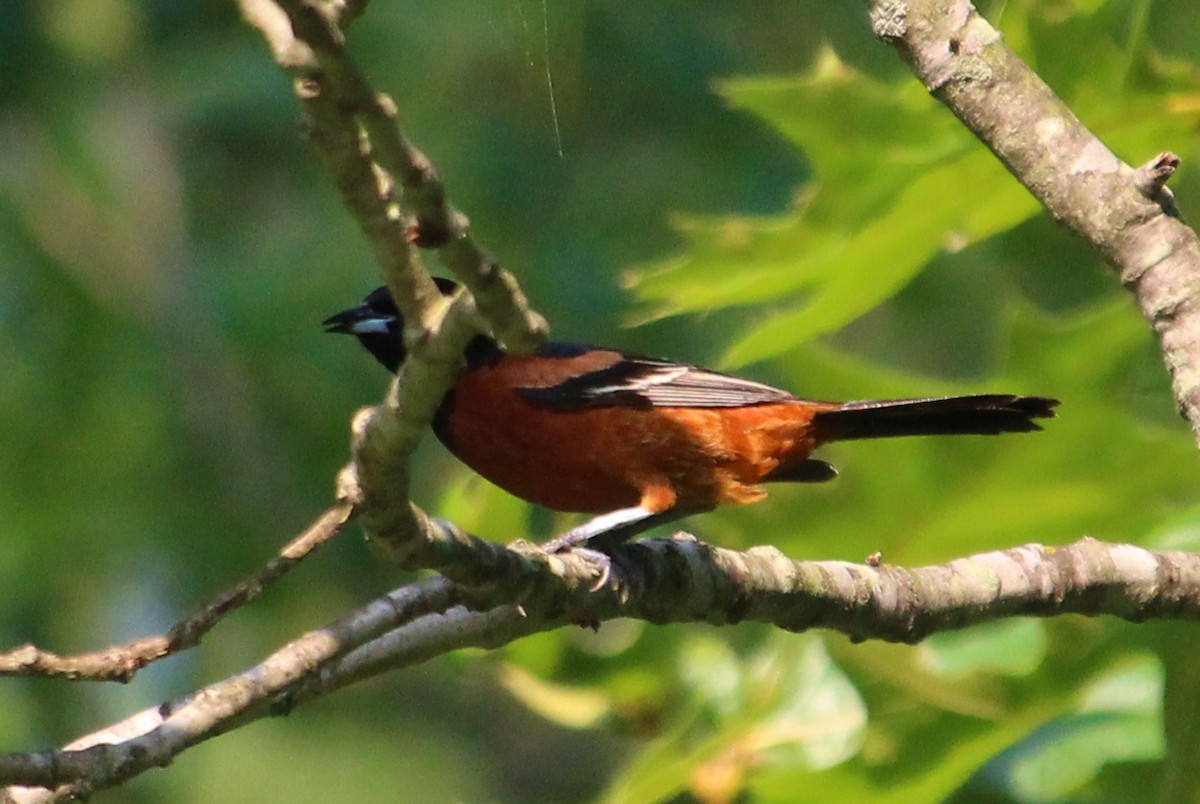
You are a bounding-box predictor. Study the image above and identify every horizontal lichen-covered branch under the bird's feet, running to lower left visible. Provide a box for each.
[0,538,1200,802]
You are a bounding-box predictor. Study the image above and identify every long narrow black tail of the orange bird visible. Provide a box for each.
[812,394,1058,442]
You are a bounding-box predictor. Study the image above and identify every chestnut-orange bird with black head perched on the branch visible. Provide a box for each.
[324,278,1058,548]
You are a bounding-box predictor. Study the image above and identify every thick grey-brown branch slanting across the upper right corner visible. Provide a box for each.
[869,0,1200,439]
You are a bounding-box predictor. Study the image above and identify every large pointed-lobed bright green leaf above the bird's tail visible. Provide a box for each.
[629,53,1037,365]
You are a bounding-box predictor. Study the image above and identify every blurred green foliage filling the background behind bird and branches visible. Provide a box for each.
[0,0,1200,802]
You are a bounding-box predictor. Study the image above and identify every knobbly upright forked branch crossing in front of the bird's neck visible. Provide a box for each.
[241,0,546,566]
